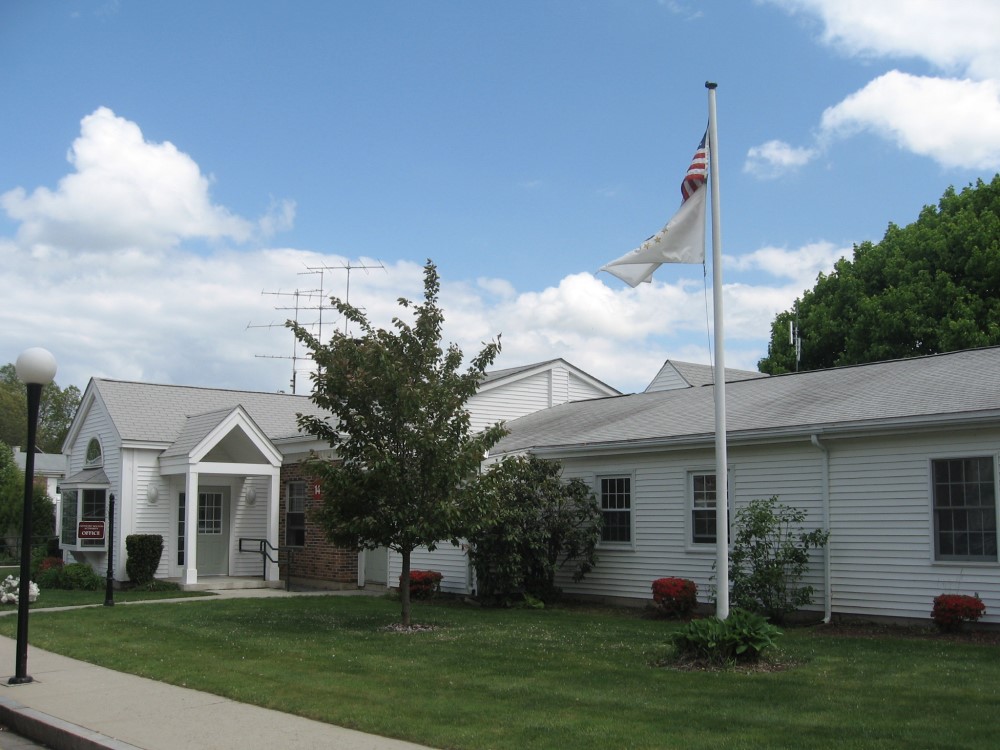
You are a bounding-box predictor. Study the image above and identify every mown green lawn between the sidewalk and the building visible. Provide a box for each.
[0,596,1000,750]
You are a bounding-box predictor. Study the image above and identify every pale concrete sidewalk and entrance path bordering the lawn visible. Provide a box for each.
[0,589,438,750]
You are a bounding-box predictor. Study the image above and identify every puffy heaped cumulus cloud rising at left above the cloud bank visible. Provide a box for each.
[0,107,253,252]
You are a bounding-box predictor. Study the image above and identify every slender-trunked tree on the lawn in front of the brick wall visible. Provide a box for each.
[289,261,504,627]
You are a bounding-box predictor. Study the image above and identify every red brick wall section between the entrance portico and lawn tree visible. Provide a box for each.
[278,463,358,588]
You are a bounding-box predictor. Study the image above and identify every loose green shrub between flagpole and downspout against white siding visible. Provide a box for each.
[729,496,830,623]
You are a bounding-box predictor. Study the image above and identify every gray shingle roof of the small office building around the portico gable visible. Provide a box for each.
[93,378,325,443]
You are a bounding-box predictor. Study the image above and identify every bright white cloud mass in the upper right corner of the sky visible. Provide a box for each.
[745,0,1000,177]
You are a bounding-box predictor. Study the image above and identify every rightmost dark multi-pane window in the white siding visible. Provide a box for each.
[931,456,997,562]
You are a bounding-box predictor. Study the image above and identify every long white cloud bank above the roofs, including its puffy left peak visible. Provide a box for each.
[0,110,839,400]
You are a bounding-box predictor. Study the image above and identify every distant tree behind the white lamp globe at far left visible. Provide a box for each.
[0,364,81,453]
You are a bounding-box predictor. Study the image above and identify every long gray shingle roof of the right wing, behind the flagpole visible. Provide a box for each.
[491,347,1000,454]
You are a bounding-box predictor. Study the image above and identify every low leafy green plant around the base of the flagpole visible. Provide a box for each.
[671,609,781,666]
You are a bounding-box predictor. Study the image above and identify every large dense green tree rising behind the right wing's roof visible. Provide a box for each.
[758,175,1000,375]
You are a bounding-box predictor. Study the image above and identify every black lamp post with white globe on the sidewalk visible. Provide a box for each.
[8,347,56,685]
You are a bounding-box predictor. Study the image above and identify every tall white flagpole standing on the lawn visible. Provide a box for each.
[705,81,729,620]
